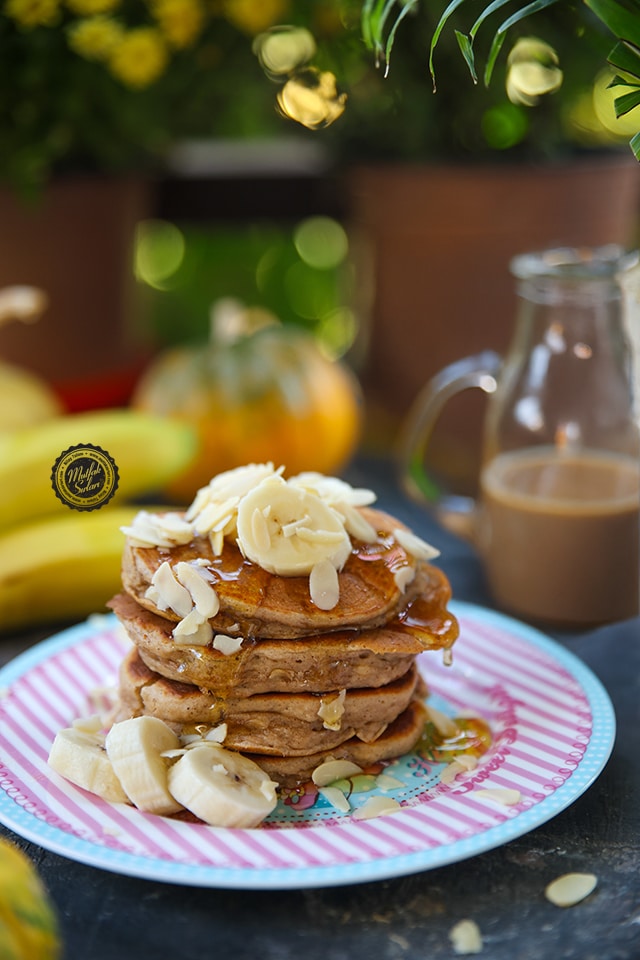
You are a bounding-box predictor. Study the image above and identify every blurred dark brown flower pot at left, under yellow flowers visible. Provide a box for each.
[0,178,148,409]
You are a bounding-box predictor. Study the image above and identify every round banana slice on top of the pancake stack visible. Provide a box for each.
[237,476,351,577]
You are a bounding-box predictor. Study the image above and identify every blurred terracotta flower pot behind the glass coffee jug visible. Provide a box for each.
[347,154,640,492]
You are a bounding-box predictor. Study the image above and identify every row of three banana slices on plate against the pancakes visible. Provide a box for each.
[49,716,277,828]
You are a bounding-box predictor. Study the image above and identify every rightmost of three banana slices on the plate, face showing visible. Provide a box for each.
[169,743,278,829]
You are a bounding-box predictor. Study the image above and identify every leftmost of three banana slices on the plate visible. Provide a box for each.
[48,727,129,803]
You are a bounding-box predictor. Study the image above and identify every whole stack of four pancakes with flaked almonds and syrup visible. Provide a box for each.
[110,465,458,785]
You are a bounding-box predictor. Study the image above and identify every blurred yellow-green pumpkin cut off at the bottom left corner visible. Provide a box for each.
[0,839,60,960]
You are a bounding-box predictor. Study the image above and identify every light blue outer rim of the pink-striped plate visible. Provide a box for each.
[0,601,616,890]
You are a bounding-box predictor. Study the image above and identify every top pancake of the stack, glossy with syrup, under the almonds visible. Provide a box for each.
[122,508,451,639]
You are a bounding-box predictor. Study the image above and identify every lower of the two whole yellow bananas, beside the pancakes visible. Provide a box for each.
[0,506,160,632]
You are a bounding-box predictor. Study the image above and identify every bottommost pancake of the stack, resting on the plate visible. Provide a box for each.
[245,700,427,788]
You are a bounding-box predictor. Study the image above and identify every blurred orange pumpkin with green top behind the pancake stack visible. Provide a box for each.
[131,324,361,502]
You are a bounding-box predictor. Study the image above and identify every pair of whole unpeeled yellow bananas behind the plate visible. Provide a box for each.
[0,409,197,633]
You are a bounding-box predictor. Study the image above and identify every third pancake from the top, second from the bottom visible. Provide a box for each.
[114,650,425,757]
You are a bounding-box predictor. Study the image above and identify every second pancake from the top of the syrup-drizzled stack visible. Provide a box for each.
[109,594,430,698]
